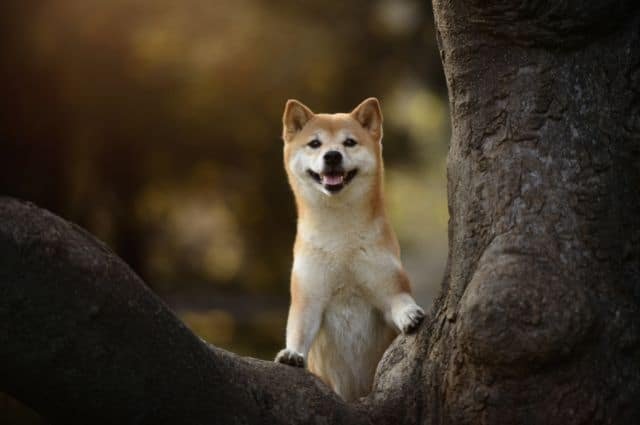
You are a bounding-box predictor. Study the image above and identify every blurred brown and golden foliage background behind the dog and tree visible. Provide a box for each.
[0,0,449,418]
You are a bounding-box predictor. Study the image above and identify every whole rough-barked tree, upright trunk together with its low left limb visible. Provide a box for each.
[0,0,640,424]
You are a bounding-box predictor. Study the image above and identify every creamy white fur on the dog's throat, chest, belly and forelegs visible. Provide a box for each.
[287,171,422,400]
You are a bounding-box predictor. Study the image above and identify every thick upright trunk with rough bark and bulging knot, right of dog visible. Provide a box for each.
[402,0,640,424]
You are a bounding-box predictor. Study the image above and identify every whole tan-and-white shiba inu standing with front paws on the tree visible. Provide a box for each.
[276,98,424,401]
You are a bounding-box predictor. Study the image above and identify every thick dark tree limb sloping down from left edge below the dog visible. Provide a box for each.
[0,198,366,424]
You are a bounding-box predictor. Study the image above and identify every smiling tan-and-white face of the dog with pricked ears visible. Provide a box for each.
[283,98,382,200]
